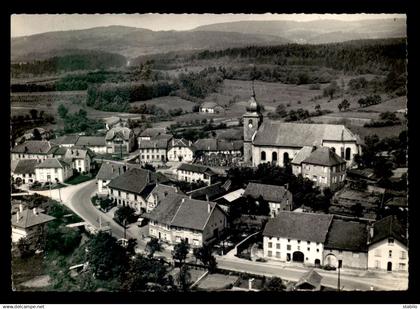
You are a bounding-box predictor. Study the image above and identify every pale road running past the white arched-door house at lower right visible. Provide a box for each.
[217,257,408,291]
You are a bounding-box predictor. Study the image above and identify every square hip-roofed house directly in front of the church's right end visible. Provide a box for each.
[291,146,346,190]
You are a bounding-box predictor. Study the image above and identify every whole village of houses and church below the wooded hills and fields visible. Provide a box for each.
[11,89,409,291]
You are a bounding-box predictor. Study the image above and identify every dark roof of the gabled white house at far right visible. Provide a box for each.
[369,216,407,245]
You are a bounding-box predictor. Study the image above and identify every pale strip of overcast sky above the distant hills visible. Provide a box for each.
[11,14,405,37]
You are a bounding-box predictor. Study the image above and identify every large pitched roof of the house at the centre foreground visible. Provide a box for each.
[147,194,223,231]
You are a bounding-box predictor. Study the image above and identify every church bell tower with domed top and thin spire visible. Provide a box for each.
[242,81,263,165]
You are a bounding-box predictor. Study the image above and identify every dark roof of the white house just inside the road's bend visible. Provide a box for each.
[108,168,156,194]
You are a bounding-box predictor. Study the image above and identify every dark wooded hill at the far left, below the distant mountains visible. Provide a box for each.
[11,51,126,77]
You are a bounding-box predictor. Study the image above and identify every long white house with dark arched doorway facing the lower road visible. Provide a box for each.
[263,211,333,266]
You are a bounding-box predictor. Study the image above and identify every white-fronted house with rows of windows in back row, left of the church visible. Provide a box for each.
[139,134,172,164]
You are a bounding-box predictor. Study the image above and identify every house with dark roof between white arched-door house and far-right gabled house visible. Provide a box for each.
[323,218,368,269]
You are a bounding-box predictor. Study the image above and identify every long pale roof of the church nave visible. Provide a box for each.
[253,121,357,147]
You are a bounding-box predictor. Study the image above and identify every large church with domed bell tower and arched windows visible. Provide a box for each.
[243,93,361,167]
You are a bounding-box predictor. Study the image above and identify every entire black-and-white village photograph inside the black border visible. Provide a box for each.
[7,13,412,301]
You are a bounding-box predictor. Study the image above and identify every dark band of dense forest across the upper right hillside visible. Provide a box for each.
[190,39,407,74]
